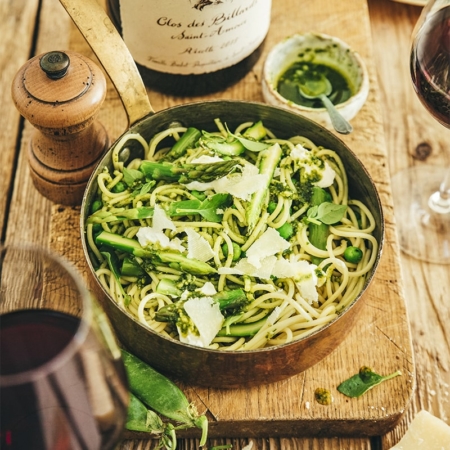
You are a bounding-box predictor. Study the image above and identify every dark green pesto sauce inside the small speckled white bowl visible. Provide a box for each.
[276,61,352,108]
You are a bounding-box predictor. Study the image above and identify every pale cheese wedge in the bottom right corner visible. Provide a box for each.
[390,410,450,450]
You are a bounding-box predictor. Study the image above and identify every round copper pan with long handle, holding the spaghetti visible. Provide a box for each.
[60,0,384,388]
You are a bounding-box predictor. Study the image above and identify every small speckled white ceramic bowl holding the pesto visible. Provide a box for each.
[262,33,369,129]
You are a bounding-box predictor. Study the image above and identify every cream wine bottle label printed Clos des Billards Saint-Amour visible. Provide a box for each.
[120,0,271,75]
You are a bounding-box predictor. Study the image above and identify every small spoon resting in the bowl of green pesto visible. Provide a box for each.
[298,76,353,134]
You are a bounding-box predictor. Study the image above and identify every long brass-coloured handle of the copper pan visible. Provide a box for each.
[60,0,155,125]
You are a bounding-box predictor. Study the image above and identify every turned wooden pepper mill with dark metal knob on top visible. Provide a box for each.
[12,51,109,206]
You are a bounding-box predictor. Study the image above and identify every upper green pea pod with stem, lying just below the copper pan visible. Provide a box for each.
[122,349,208,446]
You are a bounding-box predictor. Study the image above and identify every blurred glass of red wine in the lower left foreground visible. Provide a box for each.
[0,244,128,450]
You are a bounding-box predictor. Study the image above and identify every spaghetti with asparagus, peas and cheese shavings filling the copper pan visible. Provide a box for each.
[86,119,378,351]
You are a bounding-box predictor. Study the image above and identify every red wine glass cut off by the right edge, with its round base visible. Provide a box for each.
[392,0,450,264]
